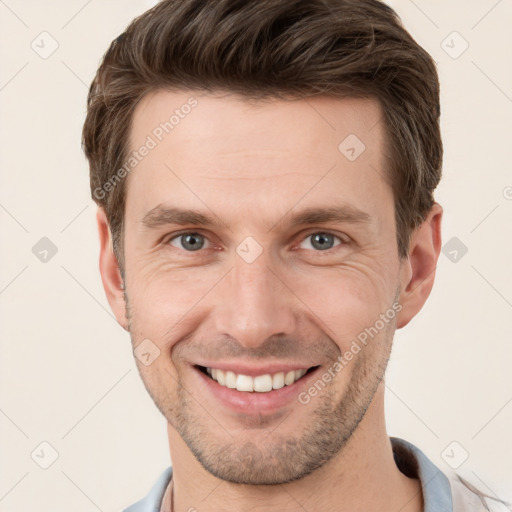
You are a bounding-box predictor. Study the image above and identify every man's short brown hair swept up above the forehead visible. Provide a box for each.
[82,0,443,270]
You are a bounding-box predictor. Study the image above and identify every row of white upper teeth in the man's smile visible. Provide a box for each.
[206,368,307,393]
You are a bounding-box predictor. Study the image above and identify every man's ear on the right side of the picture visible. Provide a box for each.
[397,203,443,329]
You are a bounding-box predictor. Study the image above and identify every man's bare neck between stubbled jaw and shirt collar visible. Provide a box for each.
[163,382,423,512]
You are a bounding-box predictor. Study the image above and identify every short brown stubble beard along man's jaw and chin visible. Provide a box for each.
[125,293,395,485]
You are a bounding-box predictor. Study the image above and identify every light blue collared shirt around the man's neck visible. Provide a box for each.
[123,437,505,512]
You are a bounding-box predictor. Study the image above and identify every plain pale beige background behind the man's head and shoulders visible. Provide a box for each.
[0,0,512,512]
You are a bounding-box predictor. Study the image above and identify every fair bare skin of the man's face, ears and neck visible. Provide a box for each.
[97,91,442,512]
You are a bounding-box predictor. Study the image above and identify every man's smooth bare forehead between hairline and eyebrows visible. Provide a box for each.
[127,91,392,227]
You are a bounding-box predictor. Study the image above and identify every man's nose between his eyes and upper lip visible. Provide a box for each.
[214,253,296,348]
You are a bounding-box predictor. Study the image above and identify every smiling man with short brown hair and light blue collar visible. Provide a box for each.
[83,0,502,512]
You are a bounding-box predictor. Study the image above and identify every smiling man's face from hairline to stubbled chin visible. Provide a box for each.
[124,92,401,484]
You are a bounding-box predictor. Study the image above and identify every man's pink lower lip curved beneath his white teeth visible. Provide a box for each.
[192,366,319,415]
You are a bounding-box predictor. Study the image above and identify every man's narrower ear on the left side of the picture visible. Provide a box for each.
[96,207,128,330]
